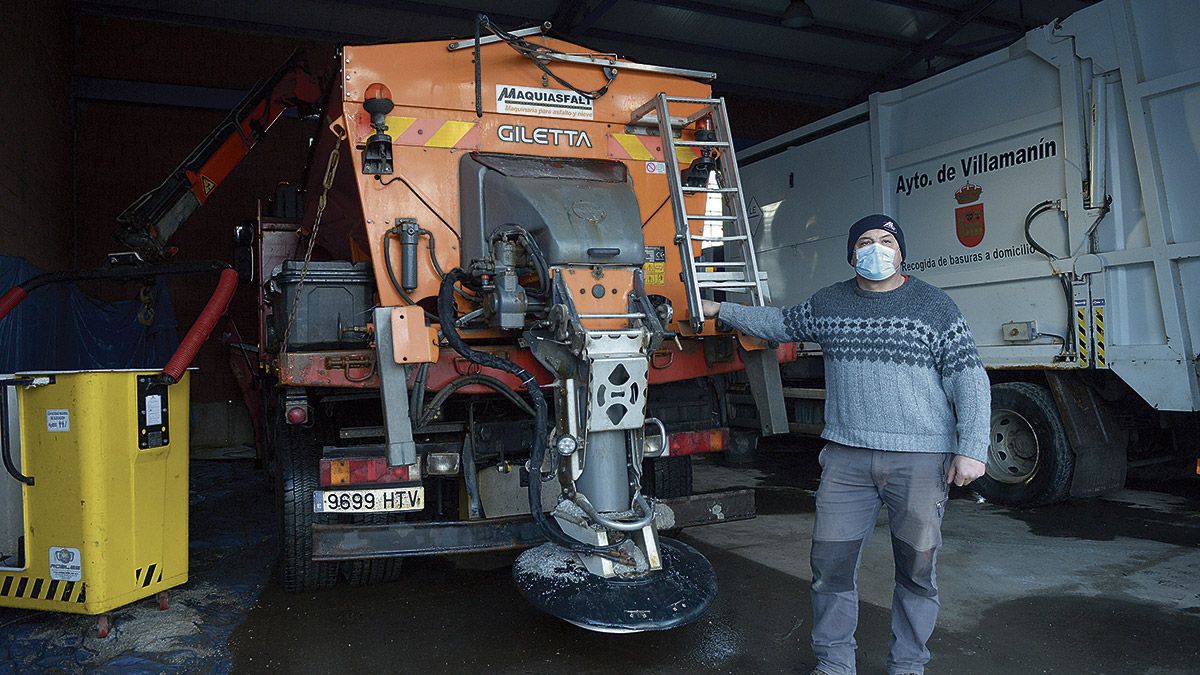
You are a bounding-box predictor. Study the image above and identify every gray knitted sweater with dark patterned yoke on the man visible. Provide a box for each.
[719,277,991,461]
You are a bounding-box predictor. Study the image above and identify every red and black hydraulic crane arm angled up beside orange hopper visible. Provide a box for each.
[116,53,322,261]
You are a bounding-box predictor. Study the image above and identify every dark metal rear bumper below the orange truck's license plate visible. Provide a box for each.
[312,490,755,561]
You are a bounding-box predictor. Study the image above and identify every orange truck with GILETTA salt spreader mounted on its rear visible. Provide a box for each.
[240,18,793,632]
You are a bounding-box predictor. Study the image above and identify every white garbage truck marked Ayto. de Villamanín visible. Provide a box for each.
[730,0,1200,506]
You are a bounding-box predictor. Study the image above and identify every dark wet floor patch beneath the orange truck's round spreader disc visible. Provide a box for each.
[230,537,859,674]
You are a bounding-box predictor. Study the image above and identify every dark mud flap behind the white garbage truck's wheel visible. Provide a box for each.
[1046,370,1129,497]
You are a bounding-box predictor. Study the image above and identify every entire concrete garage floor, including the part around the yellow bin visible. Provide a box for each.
[0,441,1200,675]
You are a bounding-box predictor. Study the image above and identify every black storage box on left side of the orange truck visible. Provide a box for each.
[266,261,374,350]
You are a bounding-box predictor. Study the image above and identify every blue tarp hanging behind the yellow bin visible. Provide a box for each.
[0,256,179,372]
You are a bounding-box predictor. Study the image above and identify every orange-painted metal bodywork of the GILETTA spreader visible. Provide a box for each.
[280,36,794,393]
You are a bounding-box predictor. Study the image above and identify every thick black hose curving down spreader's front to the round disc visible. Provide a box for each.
[438,268,618,555]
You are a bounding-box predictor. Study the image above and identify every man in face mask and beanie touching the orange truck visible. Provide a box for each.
[703,215,991,675]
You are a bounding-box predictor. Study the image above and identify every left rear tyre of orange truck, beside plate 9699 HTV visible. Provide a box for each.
[275,424,337,592]
